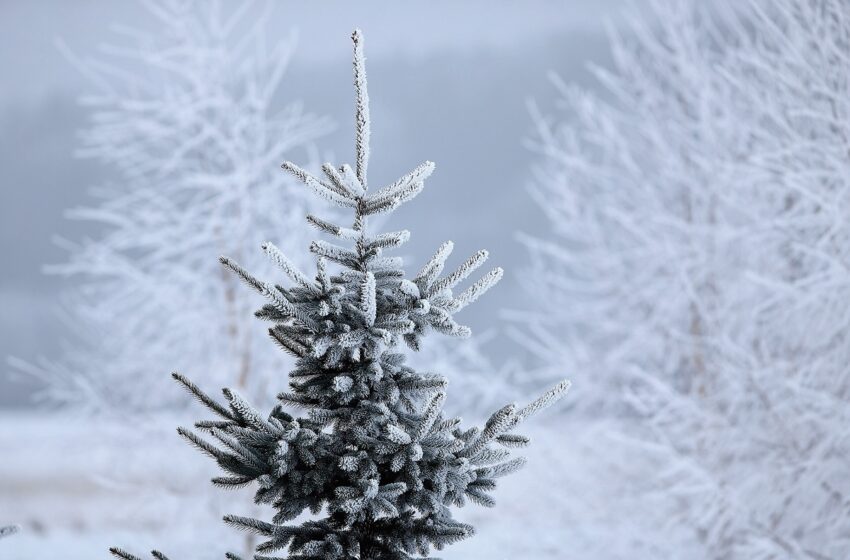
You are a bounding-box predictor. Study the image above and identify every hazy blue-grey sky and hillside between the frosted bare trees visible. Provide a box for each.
[0,0,621,406]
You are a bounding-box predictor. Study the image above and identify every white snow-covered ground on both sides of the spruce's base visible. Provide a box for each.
[0,414,688,560]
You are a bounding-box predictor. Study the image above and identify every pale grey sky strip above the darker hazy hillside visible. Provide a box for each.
[0,0,622,105]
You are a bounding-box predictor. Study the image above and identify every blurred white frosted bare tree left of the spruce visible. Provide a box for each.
[17,0,329,414]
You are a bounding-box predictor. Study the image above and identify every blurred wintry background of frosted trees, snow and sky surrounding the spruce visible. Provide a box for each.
[0,0,850,560]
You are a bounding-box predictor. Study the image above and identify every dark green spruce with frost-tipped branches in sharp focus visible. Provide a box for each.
[112,31,569,560]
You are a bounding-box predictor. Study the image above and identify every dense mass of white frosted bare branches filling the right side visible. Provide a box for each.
[517,0,850,559]
